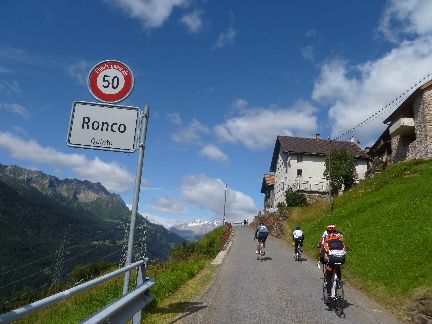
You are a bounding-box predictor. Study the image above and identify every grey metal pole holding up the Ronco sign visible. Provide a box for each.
[123,106,149,295]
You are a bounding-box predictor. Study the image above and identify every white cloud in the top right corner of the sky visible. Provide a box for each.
[378,0,432,42]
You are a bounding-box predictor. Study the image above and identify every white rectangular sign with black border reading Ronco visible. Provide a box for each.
[67,101,139,152]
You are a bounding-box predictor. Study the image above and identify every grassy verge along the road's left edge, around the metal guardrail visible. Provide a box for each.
[19,227,231,323]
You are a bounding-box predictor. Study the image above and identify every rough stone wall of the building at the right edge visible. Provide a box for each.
[406,89,432,161]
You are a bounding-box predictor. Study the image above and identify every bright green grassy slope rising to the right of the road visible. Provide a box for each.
[289,161,432,307]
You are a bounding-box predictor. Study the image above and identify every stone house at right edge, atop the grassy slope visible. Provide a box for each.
[370,81,432,163]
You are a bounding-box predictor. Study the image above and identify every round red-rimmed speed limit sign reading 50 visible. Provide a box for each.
[88,60,134,102]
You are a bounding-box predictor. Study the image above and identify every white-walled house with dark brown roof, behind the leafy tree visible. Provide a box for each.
[270,134,369,206]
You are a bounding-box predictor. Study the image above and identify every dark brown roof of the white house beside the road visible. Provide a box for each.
[270,136,369,172]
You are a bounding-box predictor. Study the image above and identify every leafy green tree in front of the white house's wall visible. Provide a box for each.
[324,149,357,190]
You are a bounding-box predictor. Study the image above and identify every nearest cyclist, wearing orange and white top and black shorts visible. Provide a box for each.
[320,232,346,303]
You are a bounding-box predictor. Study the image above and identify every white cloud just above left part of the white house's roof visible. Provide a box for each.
[214,101,317,150]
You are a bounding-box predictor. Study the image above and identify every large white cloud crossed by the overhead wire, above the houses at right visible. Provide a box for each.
[312,37,432,145]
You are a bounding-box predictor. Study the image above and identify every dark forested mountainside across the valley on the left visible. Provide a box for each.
[0,164,184,299]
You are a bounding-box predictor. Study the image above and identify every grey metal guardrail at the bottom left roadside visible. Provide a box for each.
[0,258,154,323]
